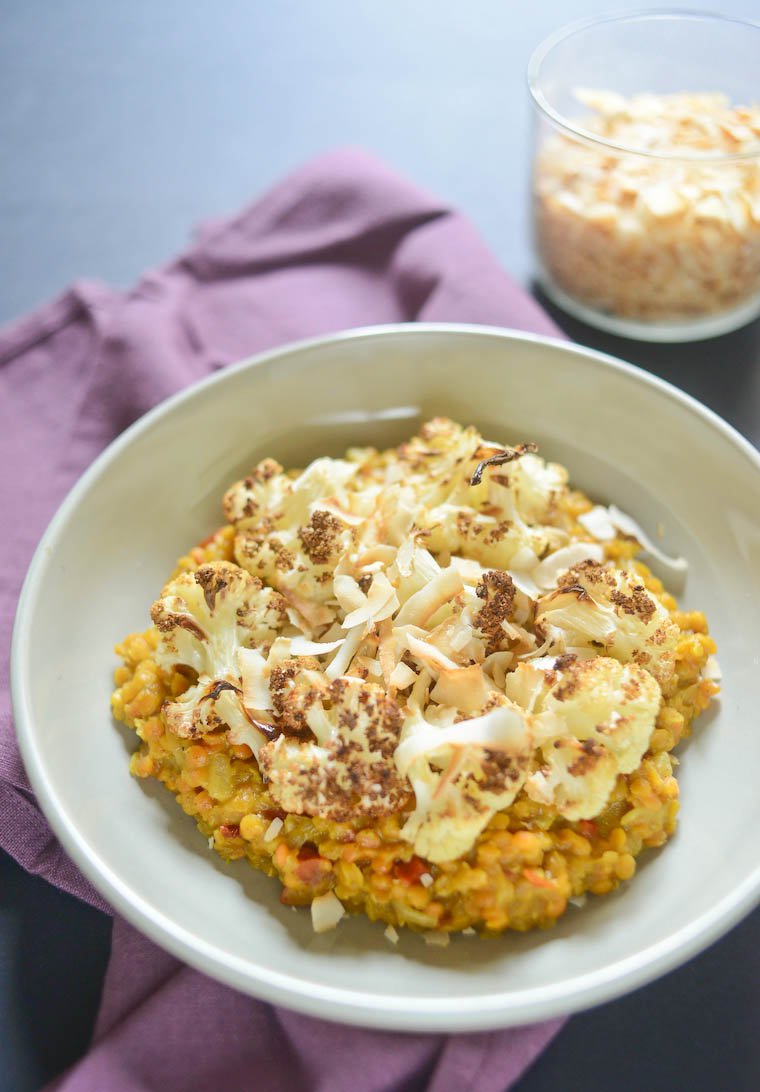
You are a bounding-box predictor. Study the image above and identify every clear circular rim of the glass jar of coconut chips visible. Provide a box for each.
[526,8,760,164]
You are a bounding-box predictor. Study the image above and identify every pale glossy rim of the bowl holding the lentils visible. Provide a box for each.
[11,322,760,1032]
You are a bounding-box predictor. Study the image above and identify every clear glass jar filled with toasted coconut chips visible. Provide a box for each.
[527,11,760,341]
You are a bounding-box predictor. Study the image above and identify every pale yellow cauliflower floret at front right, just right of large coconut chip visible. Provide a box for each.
[506,656,662,820]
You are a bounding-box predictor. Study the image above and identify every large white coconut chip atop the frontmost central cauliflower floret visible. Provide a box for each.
[395,705,532,774]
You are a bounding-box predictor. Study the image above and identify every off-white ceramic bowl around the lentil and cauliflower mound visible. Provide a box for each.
[13,325,760,1031]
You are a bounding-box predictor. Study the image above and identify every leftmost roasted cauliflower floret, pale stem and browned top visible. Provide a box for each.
[151,561,287,737]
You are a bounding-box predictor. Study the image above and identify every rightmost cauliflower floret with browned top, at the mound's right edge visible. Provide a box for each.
[536,561,678,685]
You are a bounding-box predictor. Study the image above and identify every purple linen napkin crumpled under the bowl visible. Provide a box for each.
[0,151,561,1092]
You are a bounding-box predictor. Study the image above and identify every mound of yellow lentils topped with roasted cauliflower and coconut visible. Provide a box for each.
[112,418,717,943]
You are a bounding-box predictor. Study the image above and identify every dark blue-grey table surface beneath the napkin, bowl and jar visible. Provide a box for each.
[0,0,760,1092]
